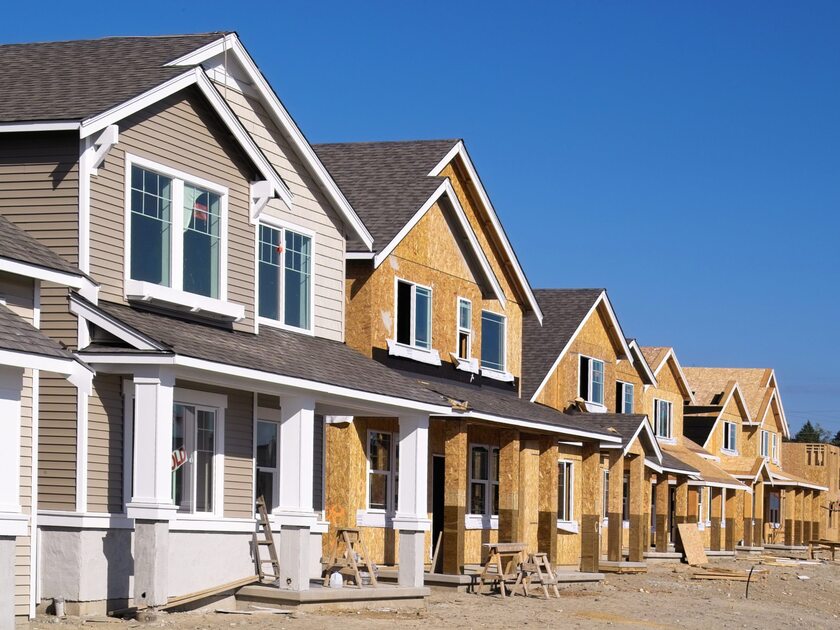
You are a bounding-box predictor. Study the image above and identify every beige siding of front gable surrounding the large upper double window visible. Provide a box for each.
[90,88,256,331]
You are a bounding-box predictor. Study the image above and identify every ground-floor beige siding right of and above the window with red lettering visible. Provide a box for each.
[176,381,254,518]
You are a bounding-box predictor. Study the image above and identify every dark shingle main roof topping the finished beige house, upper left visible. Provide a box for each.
[0,33,225,122]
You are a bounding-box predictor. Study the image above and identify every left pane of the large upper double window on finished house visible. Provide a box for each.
[131,166,172,287]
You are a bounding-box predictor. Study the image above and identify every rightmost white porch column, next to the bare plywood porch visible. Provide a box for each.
[394,415,431,587]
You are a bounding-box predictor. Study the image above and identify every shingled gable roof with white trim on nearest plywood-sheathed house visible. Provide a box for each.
[313,140,542,320]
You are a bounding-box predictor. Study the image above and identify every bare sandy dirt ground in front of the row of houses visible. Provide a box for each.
[18,559,840,630]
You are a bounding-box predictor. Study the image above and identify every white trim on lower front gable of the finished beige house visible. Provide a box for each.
[79,68,292,210]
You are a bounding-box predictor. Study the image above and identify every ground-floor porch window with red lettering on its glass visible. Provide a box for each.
[172,403,217,513]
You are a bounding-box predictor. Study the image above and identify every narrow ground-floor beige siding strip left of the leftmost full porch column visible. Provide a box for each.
[88,374,123,514]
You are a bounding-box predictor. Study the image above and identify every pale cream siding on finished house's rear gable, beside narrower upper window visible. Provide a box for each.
[220,88,345,341]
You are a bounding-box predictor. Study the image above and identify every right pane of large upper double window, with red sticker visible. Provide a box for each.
[184,184,222,298]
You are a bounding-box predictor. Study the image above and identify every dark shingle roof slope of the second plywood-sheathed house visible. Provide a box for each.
[522,289,604,400]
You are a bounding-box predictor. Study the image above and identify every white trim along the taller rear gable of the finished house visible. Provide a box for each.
[166,33,373,250]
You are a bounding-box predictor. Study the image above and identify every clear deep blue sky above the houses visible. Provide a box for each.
[0,0,840,432]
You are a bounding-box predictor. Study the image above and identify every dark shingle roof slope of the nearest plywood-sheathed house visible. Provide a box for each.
[312,140,458,252]
